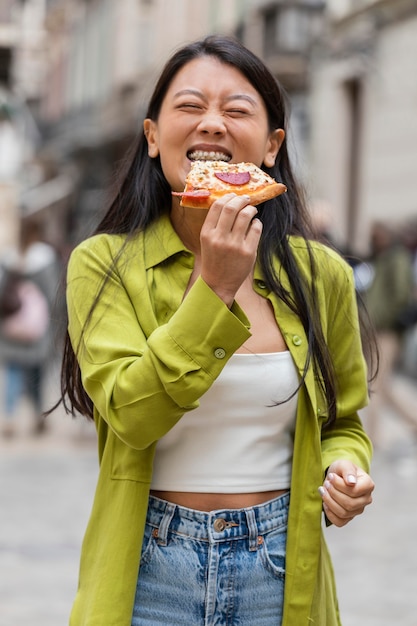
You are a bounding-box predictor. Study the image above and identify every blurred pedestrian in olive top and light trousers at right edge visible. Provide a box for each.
[362,221,417,445]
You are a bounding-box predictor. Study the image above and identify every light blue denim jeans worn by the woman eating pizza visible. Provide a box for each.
[132,493,290,626]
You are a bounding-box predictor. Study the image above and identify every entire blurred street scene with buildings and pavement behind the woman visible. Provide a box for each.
[0,0,417,626]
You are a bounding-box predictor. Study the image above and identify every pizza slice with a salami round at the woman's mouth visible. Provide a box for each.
[172,161,287,209]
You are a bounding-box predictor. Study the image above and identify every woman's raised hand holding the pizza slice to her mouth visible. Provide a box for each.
[200,194,262,307]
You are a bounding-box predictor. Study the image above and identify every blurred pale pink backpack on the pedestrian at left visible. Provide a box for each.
[1,279,49,344]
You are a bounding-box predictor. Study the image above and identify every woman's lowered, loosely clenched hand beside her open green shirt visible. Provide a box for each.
[319,460,375,526]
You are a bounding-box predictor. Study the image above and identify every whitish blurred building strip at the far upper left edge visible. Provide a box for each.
[0,0,51,254]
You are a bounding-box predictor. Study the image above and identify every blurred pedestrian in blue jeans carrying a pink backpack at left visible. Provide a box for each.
[0,219,59,437]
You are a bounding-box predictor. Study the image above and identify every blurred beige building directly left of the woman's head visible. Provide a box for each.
[40,0,254,245]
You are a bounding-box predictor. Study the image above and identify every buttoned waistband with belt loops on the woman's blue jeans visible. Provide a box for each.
[147,492,290,549]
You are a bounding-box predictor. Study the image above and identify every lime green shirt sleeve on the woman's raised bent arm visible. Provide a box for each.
[67,236,250,450]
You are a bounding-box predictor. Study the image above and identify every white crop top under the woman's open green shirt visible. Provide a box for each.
[151,351,299,493]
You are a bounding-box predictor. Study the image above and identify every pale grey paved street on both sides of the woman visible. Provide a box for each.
[0,368,417,626]
